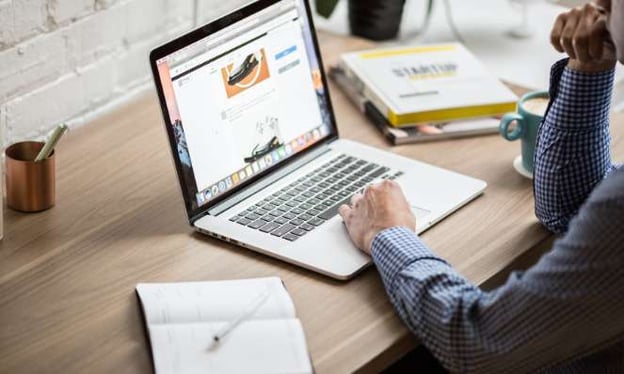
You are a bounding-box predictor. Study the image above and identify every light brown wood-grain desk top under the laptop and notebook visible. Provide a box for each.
[0,35,624,373]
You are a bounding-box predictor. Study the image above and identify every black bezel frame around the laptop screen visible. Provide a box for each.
[150,0,338,223]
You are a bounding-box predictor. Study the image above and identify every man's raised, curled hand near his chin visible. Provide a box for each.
[550,0,616,73]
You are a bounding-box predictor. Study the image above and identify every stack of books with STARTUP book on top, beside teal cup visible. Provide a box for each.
[330,43,518,144]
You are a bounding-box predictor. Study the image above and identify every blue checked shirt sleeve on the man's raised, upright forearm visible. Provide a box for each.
[534,60,614,233]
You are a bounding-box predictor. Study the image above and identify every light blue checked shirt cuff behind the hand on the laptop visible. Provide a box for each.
[371,227,450,289]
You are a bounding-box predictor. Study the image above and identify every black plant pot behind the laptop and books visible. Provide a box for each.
[349,0,405,40]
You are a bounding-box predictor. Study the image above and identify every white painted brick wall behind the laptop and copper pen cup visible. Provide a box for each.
[0,0,249,145]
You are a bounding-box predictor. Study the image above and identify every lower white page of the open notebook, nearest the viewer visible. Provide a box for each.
[150,319,313,374]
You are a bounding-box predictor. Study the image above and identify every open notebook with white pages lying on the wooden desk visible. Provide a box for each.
[136,278,313,374]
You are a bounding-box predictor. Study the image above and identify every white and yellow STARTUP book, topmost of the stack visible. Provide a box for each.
[339,43,518,127]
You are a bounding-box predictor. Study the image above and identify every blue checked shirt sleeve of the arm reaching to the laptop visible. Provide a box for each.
[373,218,624,373]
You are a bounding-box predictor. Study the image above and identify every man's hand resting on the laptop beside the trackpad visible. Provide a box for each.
[340,181,416,254]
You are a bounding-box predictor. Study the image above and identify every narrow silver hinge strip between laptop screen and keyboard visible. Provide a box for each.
[208,144,330,216]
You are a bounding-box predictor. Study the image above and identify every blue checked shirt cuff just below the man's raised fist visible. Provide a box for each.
[546,59,615,129]
